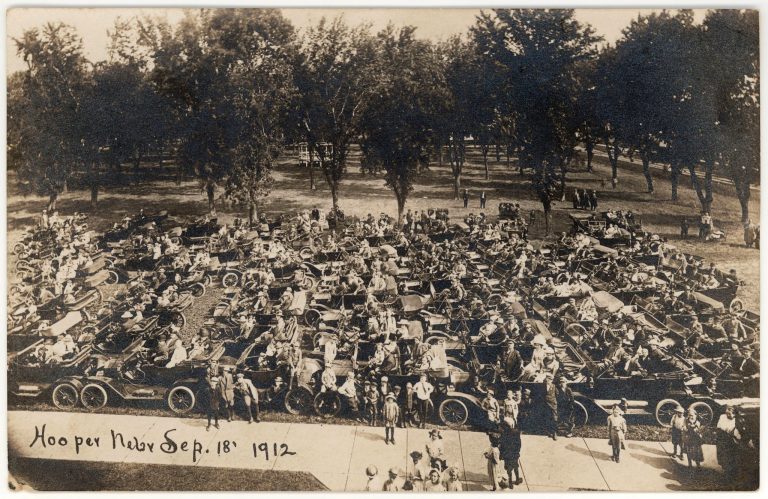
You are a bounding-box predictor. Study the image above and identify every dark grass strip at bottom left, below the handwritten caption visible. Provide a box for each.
[8,458,327,491]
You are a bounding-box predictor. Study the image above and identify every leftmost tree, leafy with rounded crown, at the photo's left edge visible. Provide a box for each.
[9,23,88,209]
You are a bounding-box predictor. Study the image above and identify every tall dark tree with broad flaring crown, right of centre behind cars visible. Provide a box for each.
[472,9,600,230]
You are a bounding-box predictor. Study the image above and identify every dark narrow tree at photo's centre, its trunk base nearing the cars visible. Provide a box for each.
[361,25,446,226]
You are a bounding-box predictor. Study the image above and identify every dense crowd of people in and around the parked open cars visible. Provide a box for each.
[9,199,759,490]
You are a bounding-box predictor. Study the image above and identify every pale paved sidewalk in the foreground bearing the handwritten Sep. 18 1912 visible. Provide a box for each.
[8,411,733,491]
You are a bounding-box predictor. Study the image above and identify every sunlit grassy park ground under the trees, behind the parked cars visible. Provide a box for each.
[7,144,760,311]
